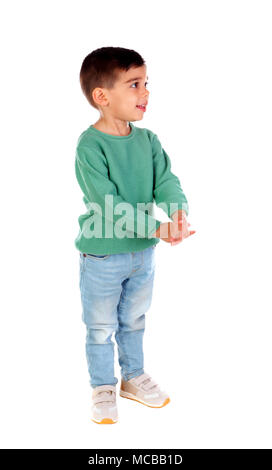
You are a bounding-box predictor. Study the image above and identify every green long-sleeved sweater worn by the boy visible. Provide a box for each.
[75,122,189,255]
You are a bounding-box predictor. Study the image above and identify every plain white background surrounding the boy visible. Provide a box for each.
[0,0,272,449]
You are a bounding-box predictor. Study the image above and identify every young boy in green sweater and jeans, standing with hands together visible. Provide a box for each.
[75,47,194,424]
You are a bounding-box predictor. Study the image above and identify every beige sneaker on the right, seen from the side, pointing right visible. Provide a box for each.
[120,373,170,408]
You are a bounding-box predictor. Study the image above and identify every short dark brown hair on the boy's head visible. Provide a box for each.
[79,47,145,109]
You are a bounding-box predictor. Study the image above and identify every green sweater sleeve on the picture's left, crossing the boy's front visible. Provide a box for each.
[75,145,161,238]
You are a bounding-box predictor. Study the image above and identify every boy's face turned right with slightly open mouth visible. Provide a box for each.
[101,65,149,121]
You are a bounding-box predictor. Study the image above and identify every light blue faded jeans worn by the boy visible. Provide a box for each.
[77,245,156,388]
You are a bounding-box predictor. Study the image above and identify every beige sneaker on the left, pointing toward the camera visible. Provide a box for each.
[92,385,118,424]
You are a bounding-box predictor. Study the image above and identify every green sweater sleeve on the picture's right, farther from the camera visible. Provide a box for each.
[152,134,189,217]
